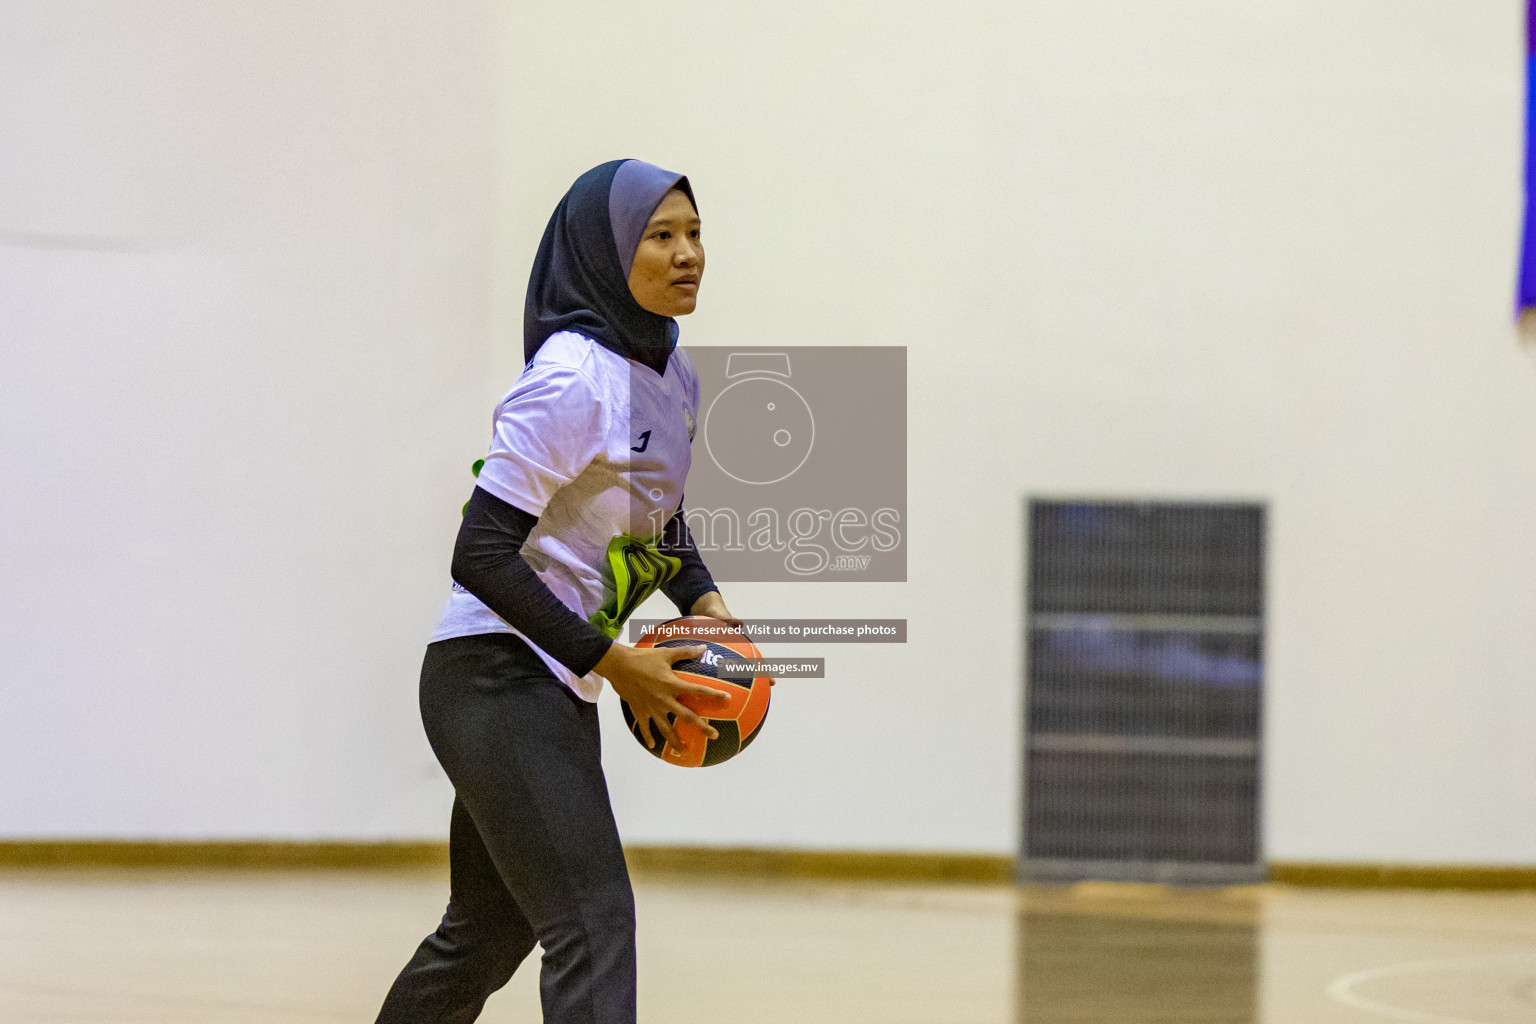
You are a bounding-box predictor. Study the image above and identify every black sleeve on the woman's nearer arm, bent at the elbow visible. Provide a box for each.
[453,487,611,676]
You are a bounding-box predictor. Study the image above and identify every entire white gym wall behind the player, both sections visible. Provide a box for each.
[0,0,1536,863]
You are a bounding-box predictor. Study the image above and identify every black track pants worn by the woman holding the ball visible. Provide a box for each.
[378,634,634,1024]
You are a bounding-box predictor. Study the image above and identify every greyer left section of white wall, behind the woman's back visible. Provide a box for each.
[0,0,498,837]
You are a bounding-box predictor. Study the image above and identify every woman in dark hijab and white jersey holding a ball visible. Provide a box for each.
[378,160,740,1024]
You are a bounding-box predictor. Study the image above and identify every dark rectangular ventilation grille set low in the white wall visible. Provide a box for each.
[1025,502,1264,880]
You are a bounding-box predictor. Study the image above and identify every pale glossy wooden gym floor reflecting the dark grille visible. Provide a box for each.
[0,870,1536,1024]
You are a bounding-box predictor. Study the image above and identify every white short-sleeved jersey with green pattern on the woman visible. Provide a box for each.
[432,332,699,702]
